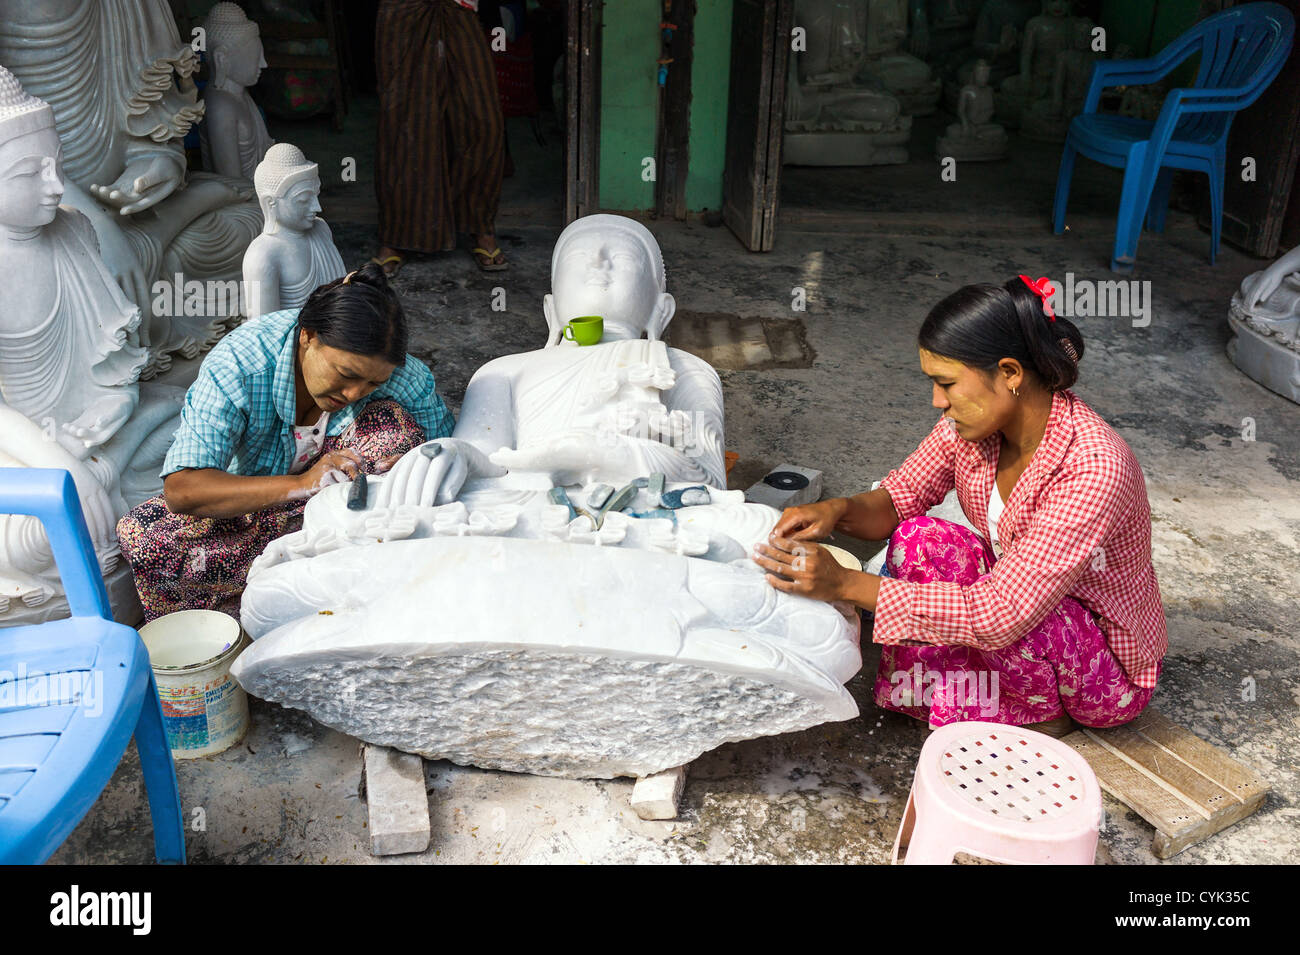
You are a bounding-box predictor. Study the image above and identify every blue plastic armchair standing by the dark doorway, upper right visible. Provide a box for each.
[1052,3,1295,273]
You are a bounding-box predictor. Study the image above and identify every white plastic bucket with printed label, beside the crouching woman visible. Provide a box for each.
[140,611,248,759]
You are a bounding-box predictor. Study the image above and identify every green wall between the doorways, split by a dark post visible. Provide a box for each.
[601,0,732,212]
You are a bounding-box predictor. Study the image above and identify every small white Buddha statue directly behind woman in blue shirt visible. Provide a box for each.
[243,143,347,317]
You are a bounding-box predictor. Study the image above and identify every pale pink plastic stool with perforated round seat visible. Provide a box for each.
[893,721,1101,865]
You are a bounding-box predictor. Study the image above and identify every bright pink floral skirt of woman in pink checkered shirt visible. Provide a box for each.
[875,517,1158,726]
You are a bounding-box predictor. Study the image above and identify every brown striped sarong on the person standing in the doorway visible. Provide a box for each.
[374,0,506,252]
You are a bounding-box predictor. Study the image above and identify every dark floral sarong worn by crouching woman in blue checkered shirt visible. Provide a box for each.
[117,400,425,621]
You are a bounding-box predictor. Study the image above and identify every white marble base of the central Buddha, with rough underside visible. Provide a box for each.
[233,478,862,778]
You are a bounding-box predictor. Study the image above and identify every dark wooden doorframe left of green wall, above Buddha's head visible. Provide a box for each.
[564,0,605,225]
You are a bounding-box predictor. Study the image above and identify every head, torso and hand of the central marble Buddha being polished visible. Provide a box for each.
[380,214,727,504]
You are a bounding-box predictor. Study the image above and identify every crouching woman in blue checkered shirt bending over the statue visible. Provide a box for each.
[117,265,455,620]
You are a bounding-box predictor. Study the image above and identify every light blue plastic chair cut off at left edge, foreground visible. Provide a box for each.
[0,468,185,864]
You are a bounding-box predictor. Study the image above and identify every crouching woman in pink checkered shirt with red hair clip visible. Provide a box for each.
[754,275,1169,734]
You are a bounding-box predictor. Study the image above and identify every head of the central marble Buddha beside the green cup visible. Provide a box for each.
[542,214,676,346]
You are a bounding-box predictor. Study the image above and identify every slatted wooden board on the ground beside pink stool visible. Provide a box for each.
[1062,709,1269,859]
